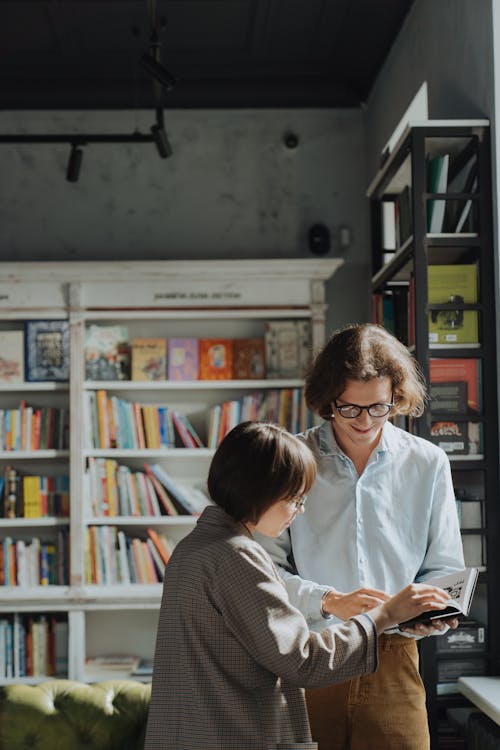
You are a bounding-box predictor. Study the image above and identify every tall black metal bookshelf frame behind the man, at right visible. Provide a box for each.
[367,121,500,750]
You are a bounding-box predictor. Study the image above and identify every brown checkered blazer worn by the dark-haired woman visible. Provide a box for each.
[145,506,376,750]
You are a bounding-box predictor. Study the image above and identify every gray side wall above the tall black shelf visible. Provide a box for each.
[366,0,498,174]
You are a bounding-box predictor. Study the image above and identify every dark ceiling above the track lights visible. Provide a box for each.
[0,0,414,109]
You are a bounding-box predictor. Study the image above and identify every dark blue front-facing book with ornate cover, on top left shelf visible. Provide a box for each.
[24,320,69,382]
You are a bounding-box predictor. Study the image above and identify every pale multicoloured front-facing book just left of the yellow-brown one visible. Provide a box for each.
[85,324,130,380]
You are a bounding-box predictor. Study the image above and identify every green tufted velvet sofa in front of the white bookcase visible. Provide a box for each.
[0,680,151,750]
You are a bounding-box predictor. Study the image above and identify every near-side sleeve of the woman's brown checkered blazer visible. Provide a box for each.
[211,542,377,688]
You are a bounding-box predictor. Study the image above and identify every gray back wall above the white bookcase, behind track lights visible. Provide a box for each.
[0,109,368,334]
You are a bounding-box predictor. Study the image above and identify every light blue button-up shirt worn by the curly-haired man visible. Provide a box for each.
[258,422,464,630]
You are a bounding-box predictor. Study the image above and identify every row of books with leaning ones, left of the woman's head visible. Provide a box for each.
[84,457,209,517]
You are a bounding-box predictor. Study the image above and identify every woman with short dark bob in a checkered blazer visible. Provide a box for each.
[145,422,447,750]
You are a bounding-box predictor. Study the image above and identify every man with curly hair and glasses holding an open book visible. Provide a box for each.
[259,324,464,750]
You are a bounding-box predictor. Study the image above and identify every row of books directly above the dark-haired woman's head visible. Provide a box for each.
[208,388,313,449]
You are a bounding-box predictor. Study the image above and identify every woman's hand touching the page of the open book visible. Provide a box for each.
[370,583,450,635]
